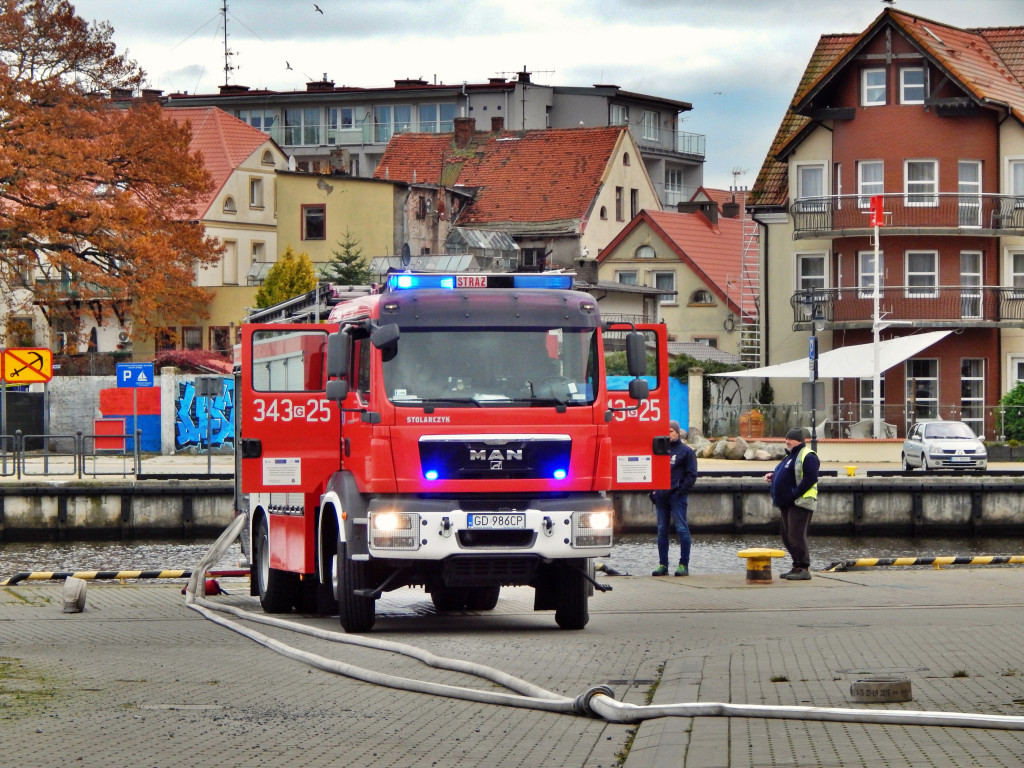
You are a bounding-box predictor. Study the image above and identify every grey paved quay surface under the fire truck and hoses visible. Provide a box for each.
[0,551,1024,768]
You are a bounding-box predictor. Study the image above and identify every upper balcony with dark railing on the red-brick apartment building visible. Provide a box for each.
[790,193,1024,240]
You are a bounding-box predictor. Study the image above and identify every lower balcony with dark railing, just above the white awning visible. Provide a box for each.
[790,286,1024,331]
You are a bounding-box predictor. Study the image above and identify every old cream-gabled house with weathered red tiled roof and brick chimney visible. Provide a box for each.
[375,118,660,269]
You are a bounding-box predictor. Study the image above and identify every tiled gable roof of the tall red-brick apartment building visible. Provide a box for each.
[751,8,1024,206]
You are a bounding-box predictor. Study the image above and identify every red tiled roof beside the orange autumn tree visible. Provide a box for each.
[164,106,270,218]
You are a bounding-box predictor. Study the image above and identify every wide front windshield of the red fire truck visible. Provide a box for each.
[383,328,597,408]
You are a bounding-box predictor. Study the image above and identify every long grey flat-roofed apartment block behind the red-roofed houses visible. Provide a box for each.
[164,69,705,208]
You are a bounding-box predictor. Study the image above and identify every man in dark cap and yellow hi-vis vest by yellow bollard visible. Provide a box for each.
[765,427,821,582]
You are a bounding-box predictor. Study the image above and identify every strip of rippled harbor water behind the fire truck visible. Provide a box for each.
[0,534,1024,580]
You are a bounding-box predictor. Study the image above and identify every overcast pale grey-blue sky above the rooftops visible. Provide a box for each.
[72,0,1024,188]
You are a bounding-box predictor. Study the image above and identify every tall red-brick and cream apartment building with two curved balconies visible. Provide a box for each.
[749,7,1024,437]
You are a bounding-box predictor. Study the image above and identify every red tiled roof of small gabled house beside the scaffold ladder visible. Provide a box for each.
[598,208,743,312]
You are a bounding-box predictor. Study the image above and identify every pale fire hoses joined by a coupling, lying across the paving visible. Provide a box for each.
[185,516,1024,730]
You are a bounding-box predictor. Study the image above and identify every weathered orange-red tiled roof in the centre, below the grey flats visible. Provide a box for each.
[374,126,626,224]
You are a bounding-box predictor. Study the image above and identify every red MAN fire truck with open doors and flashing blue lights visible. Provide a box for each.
[238,272,669,632]
